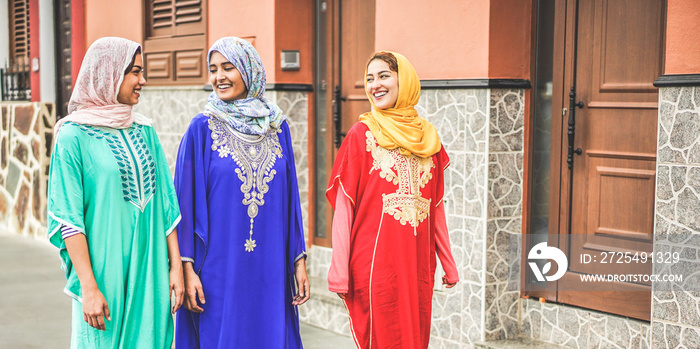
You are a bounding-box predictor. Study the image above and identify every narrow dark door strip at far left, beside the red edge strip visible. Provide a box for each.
[54,0,73,119]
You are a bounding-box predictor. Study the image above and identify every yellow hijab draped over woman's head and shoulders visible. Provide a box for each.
[360,51,441,157]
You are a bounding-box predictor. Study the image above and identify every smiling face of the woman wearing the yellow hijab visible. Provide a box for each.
[365,59,399,109]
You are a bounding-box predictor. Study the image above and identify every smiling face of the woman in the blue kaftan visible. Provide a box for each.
[209,51,248,101]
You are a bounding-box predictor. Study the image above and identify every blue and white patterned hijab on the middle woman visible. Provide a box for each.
[204,36,287,135]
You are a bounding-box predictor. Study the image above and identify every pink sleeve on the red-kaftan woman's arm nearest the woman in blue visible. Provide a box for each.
[328,195,353,293]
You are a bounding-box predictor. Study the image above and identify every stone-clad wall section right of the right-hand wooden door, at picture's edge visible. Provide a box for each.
[651,86,700,348]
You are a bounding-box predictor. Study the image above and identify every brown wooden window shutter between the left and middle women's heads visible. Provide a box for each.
[144,0,207,85]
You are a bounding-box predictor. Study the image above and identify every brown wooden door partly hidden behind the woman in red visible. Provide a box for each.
[314,0,376,246]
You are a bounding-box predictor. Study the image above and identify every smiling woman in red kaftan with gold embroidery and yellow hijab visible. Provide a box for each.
[326,51,459,349]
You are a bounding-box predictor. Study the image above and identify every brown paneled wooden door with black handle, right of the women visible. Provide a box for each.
[557,0,665,320]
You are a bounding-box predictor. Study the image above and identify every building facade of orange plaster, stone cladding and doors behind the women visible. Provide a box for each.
[0,0,700,348]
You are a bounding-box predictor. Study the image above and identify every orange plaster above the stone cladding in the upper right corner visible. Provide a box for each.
[664,0,700,74]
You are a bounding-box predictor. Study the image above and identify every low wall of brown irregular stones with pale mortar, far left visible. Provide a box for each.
[0,102,56,238]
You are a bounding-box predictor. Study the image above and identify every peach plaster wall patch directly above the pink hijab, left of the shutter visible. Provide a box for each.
[85,0,144,49]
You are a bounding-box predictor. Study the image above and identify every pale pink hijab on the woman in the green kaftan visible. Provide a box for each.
[54,37,151,133]
